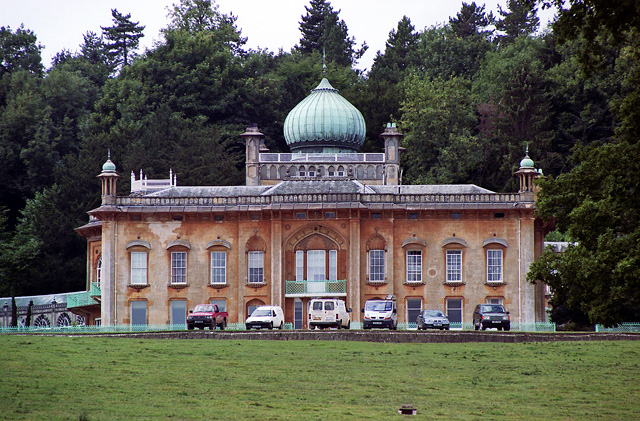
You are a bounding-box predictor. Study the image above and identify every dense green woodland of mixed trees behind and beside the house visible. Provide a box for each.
[0,0,640,324]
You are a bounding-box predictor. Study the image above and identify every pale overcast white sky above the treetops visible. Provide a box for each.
[0,0,553,69]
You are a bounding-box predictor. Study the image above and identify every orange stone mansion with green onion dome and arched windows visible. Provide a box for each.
[71,78,548,329]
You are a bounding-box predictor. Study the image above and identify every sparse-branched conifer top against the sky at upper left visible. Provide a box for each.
[101,9,145,68]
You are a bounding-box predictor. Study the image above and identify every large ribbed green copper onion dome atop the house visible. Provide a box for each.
[284,78,366,153]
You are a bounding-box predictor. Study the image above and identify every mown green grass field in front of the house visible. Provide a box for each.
[0,335,640,420]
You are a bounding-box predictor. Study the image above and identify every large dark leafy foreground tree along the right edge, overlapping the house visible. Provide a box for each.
[527,1,640,325]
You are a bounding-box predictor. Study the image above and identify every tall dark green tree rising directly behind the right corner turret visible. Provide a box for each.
[474,37,561,191]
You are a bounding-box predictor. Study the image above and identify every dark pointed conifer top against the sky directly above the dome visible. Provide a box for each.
[296,0,368,67]
